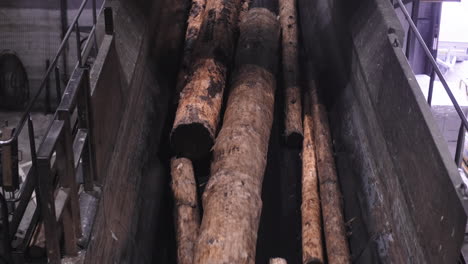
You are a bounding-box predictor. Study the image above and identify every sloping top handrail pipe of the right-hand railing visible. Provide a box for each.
[397,0,468,129]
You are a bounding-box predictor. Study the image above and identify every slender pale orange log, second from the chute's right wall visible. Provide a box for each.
[301,87,323,264]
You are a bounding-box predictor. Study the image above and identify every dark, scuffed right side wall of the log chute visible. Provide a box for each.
[299,0,466,263]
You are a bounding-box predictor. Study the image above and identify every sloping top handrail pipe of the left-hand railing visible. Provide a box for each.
[0,0,88,146]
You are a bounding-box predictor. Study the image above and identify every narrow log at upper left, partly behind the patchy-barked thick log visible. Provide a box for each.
[175,0,206,102]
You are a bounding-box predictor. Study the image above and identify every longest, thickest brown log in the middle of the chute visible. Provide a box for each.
[194,8,279,264]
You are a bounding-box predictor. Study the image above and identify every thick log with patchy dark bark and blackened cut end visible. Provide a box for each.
[171,0,245,160]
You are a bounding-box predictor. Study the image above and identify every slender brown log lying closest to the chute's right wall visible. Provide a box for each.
[308,75,351,264]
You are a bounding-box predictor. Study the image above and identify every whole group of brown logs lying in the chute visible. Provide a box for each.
[171,0,350,264]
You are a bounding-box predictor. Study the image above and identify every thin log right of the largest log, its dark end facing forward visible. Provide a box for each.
[279,0,303,148]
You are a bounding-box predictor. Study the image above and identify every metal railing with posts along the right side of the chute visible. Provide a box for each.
[396,0,468,167]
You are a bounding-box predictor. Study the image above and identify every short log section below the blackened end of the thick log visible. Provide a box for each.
[171,158,200,264]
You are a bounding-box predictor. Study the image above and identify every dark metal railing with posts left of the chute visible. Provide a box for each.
[0,0,105,263]
